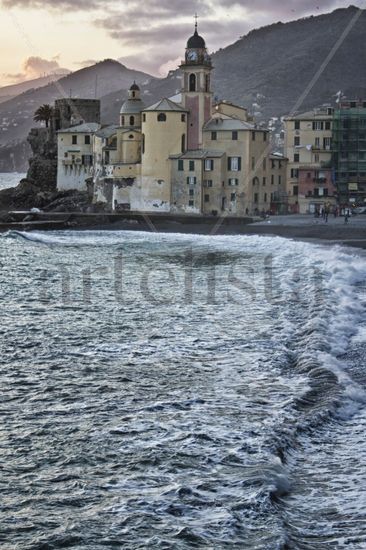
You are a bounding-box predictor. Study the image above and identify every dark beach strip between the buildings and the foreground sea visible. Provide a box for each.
[0,214,366,249]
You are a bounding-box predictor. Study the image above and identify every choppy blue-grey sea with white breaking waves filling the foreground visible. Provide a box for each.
[0,230,366,550]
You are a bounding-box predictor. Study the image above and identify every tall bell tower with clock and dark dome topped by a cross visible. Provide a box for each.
[180,15,212,150]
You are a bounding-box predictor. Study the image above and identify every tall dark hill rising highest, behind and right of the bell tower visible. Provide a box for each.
[102,6,366,122]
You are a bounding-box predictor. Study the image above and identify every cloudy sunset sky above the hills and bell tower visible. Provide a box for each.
[0,0,366,86]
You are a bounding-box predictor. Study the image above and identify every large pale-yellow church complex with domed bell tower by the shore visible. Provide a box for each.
[58,22,286,216]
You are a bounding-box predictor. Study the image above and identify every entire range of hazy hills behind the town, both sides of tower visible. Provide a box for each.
[0,6,366,170]
